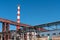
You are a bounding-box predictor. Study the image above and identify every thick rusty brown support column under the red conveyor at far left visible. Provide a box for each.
[2,22,9,40]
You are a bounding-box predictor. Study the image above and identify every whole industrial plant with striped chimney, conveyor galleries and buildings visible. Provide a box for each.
[0,5,60,40]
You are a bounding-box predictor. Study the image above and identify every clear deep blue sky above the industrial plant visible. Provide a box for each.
[0,0,60,29]
